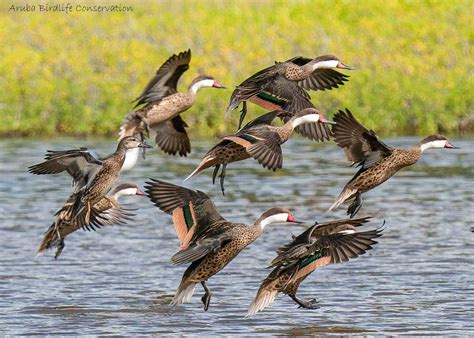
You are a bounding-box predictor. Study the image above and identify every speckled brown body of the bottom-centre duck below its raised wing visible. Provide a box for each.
[189,224,259,282]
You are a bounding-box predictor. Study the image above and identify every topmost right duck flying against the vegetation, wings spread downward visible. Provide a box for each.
[226,55,353,130]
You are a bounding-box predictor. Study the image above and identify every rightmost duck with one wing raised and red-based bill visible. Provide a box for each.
[329,109,456,217]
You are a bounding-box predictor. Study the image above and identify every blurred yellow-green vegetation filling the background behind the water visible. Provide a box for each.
[0,0,474,136]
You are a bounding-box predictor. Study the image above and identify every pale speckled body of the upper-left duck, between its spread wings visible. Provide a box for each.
[140,93,194,126]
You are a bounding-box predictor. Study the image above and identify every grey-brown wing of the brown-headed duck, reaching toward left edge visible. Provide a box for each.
[28,148,102,191]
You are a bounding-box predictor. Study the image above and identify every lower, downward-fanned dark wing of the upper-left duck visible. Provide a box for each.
[152,115,191,156]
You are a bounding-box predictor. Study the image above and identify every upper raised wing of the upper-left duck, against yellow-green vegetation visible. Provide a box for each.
[134,49,191,107]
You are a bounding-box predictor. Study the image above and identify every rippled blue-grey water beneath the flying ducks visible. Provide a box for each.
[0,138,474,336]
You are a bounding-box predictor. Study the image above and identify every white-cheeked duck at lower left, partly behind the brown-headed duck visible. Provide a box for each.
[38,183,144,259]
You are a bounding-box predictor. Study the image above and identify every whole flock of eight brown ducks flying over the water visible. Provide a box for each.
[29,50,455,316]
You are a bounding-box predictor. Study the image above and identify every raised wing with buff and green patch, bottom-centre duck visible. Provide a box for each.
[145,179,224,249]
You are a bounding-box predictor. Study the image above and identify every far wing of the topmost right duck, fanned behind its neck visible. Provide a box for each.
[286,56,349,91]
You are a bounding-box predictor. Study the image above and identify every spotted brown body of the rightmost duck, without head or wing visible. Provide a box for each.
[347,149,421,192]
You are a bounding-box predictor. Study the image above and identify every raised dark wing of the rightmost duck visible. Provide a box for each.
[332,109,392,169]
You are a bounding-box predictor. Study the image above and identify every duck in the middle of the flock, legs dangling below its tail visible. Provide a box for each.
[185,108,332,195]
